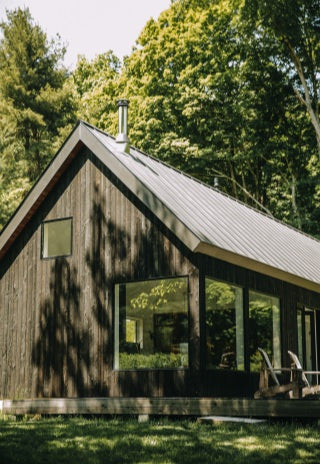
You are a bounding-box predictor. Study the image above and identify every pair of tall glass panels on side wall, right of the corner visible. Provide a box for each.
[205,277,281,372]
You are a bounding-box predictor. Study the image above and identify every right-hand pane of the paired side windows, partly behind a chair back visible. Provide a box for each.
[249,291,281,372]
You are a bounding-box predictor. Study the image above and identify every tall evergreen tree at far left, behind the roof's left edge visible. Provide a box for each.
[0,8,75,229]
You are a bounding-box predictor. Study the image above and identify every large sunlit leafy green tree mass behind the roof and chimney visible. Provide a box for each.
[73,0,316,227]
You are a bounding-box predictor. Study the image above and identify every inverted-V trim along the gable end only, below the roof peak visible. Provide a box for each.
[0,121,200,259]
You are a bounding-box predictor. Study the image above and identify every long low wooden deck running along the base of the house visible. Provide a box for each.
[0,398,320,418]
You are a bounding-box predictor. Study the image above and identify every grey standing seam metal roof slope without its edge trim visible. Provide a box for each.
[87,126,320,283]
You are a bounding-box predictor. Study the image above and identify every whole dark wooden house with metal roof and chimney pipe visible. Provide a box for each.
[0,101,320,414]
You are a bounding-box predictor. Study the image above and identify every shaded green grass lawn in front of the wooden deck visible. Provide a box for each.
[0,418,320,464]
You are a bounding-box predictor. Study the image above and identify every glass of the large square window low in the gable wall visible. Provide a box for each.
[114,277,189,369]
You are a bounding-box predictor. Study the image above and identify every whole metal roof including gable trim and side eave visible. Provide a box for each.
[0,122,320,292]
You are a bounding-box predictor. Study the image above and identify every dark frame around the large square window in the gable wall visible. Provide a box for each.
[111,274,191,372]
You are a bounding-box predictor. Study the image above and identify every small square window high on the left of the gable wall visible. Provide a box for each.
[41,218,72,258]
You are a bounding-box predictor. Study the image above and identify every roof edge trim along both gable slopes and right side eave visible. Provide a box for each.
[0,121,320,293]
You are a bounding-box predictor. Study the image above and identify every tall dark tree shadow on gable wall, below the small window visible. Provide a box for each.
[32,258,91,397]
